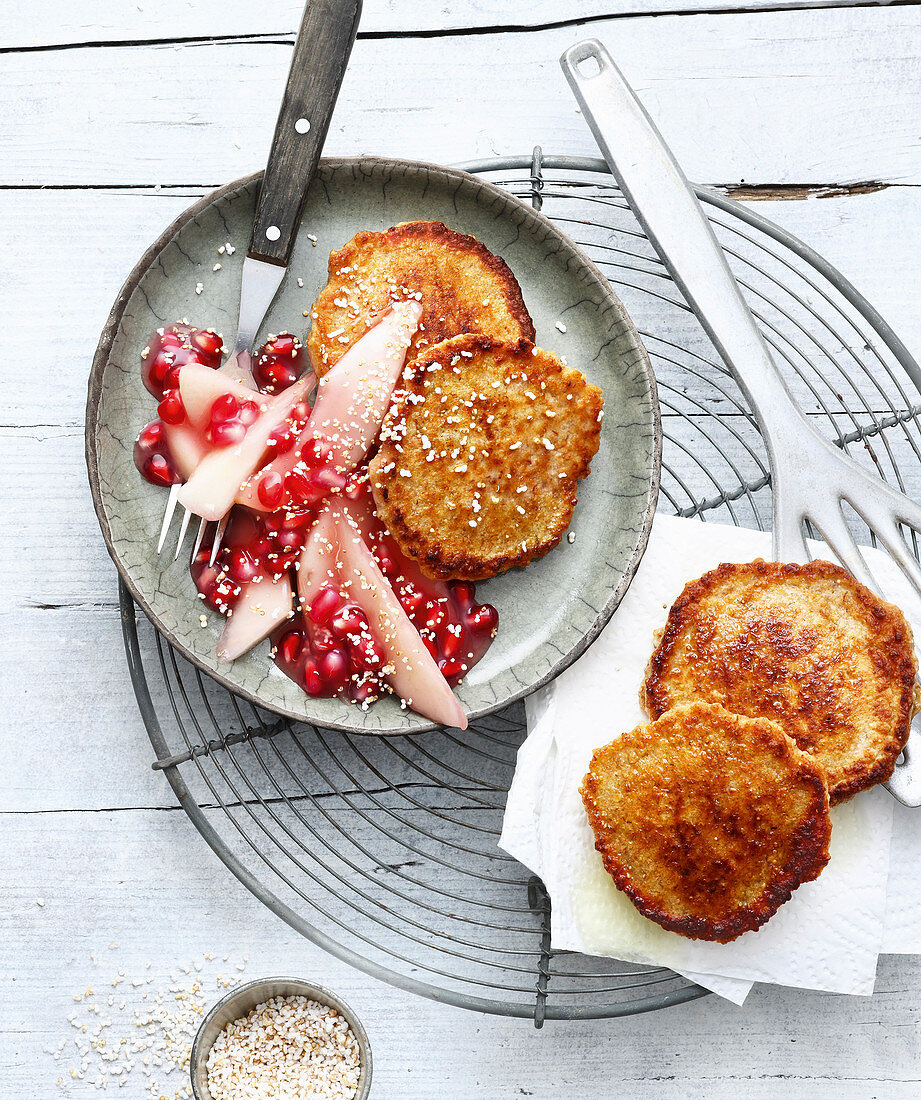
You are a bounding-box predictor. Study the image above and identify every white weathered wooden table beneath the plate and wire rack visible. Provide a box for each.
[0,0,921,1100]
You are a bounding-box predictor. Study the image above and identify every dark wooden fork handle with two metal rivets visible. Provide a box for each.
[249,0,361,266]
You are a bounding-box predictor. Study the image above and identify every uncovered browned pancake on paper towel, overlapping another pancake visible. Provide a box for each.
[581,703,832,943]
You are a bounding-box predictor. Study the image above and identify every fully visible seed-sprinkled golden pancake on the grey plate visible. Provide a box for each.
[370,333,603,581]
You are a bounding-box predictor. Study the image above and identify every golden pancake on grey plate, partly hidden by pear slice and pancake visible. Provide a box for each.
[307,221,534,377]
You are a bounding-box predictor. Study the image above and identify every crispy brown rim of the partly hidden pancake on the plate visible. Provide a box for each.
[306,221,536,377]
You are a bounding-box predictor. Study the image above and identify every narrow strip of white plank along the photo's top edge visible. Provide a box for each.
[0,0,885,50]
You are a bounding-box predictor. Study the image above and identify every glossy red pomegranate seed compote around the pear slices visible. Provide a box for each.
[134,323,498,705]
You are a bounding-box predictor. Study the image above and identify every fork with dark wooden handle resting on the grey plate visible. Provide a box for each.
[156,0,362,564]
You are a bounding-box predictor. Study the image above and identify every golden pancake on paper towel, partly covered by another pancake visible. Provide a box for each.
[644,561,917,805]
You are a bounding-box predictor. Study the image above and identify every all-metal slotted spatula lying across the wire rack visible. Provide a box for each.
[560,40,921,806]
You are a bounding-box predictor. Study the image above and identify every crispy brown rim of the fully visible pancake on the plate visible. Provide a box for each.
[371,332,604,581]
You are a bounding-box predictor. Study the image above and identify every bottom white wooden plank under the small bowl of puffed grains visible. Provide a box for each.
[0,811,921,1100]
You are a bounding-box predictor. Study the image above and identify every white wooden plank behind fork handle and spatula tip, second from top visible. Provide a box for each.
[0,7,921,186]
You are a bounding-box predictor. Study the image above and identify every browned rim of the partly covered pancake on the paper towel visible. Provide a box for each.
[640,559,921,805]
